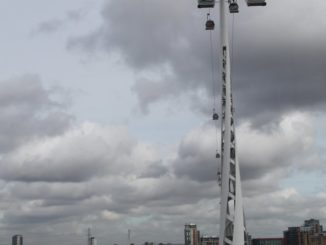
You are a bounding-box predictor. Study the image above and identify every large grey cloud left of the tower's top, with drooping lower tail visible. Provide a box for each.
[68,1,213,111]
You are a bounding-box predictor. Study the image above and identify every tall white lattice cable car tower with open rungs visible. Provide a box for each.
[198,0,266,245]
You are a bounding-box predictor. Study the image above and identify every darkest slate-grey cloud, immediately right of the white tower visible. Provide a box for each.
[234,37,326,121]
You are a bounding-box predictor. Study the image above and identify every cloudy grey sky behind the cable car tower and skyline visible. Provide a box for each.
[0,0,326,245]
